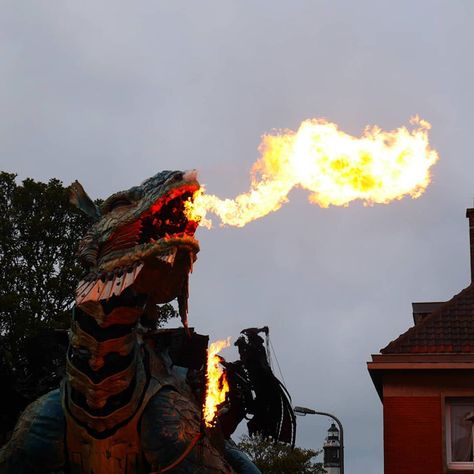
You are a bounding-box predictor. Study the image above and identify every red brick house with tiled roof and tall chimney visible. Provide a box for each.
[368,209,474,474]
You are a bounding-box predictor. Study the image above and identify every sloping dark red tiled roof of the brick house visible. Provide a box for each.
[380,284,474,354]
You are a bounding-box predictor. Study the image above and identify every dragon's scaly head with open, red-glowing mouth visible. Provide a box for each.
[70,171,199,325]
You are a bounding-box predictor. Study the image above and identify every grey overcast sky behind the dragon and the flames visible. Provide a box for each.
[0,0,474,474]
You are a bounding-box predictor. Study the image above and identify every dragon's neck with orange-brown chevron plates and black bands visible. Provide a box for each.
[65,292,148,437]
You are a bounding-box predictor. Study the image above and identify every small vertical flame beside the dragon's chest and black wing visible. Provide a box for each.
[203,337,230,427]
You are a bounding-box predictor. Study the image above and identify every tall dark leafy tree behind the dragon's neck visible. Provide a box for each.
[0,172,90,441]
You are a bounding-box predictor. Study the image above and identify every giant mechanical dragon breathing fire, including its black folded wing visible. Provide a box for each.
[0,171,295,474]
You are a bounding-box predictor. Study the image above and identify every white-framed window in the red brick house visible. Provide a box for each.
[446,397,474,472]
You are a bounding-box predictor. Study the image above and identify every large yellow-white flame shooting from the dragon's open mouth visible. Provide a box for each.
[186,116,438,228]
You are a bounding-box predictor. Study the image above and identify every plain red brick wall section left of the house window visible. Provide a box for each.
[383,397,443,474]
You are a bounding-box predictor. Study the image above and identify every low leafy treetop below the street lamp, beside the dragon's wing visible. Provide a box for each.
[238,435,326,474]
